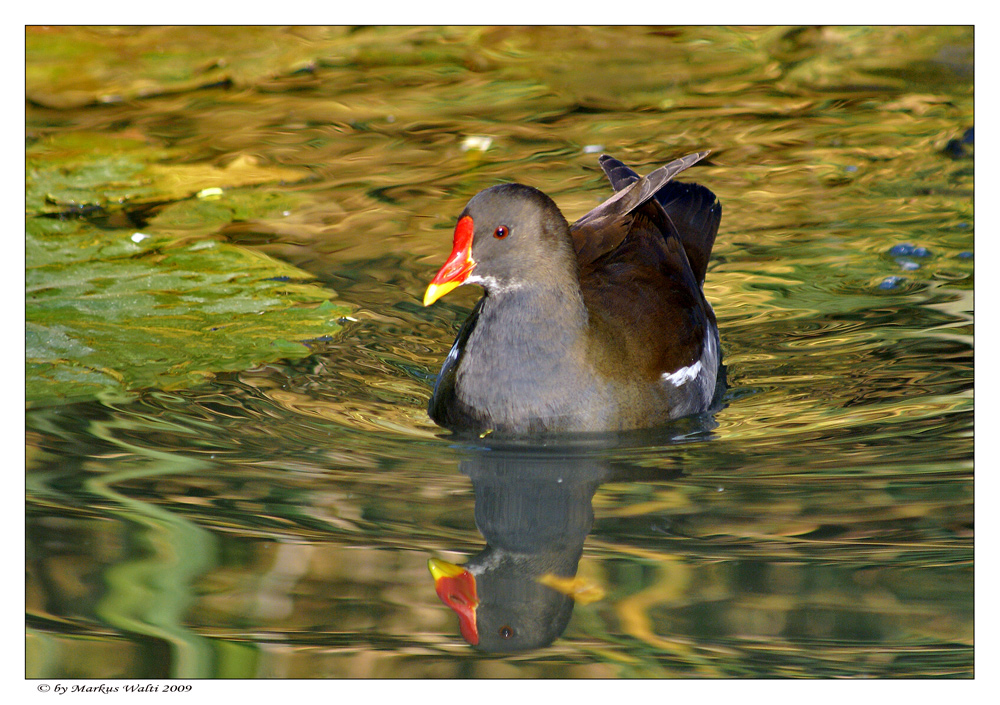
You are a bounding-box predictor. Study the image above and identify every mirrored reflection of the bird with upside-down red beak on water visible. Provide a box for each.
[428,434,692,652]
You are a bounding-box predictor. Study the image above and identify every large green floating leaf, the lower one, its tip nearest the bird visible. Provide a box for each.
[25,217,349,404]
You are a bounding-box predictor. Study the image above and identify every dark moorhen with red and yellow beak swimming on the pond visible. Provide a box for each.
[424,152,722,434]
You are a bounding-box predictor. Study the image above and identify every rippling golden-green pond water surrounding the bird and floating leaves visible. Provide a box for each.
[26,27,974,679]
